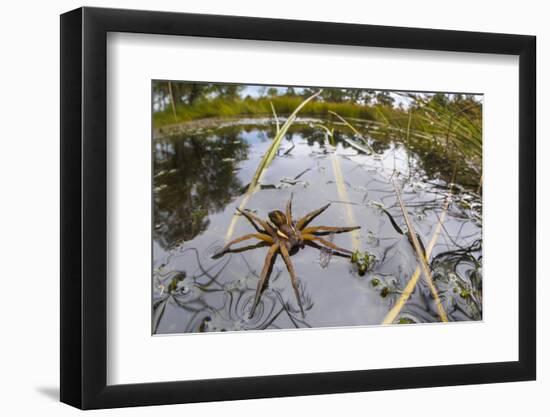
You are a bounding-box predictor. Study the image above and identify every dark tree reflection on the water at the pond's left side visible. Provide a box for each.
[154,128,249,249]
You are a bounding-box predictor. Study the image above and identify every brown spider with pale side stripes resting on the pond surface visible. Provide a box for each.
[214,195,361,317]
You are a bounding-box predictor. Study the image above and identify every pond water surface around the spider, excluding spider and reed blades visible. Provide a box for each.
[152,115,482,334]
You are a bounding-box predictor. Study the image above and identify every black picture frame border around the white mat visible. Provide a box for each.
[60,7,536,409]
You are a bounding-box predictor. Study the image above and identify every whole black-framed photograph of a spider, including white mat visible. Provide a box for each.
[61,8,536,409]
